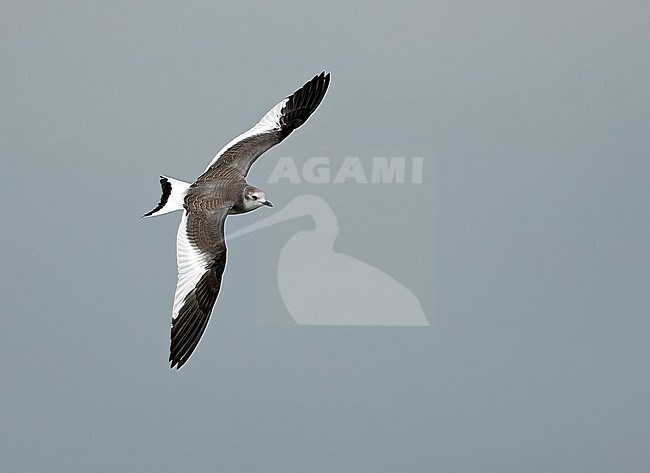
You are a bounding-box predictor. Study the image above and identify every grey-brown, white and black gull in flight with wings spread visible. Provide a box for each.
[143,72,330,369]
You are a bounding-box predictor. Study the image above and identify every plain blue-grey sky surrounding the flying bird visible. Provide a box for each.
[0,1,650,473]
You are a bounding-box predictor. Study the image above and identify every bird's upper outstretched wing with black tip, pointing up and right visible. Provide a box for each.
[199,72,330,179]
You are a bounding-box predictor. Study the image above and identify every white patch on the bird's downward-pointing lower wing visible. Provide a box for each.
[172,212,208,319]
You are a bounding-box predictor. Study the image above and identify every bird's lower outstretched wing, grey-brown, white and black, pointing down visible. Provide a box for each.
[169,207,229,369]
